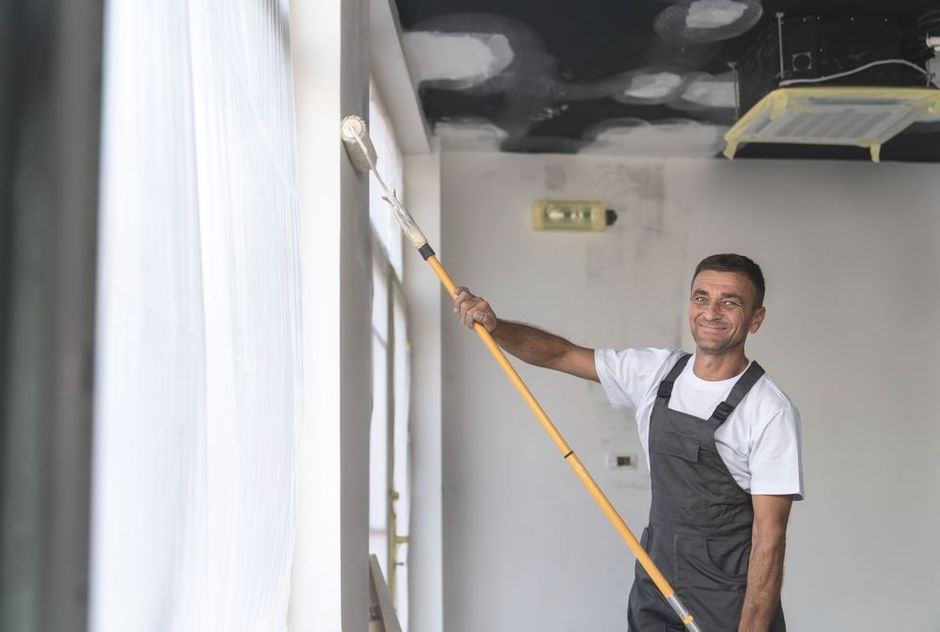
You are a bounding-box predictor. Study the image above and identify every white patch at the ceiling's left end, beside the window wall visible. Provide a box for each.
[402,31,513,89]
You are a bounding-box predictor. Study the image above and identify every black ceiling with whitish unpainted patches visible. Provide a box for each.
[396,0,940,162]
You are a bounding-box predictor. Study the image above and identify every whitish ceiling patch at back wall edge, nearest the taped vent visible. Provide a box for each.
[578,119,727,158]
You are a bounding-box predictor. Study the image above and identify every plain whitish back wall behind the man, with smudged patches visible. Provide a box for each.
[441,153,940,632]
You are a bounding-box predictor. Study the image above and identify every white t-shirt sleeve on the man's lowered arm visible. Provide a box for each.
[749,402,803,500]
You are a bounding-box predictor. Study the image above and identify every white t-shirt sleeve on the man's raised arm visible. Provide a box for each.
[594,347,681,408]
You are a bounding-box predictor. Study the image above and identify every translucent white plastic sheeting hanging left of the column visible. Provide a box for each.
[90,0,302,632]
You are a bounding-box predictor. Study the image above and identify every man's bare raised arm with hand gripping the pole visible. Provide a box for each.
[454,287,598,382]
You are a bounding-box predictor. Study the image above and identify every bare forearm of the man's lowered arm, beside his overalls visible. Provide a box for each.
[738,532,786,632]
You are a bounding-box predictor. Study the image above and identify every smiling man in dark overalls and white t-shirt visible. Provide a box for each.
[454,254,803,632]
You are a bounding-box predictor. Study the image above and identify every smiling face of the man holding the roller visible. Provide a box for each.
[689,270,765,355]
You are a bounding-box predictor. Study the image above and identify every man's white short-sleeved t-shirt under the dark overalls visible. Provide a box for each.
[594,348,803,500]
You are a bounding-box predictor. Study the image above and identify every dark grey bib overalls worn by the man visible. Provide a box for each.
[627,355,786,632]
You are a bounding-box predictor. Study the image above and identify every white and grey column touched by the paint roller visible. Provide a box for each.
[290,0,372,632]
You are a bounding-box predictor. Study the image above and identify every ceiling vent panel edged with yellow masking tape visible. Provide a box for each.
[724,86,940,162]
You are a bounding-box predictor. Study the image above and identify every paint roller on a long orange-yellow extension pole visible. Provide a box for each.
[340,116,701,632]
